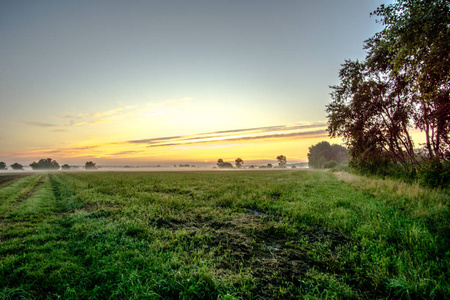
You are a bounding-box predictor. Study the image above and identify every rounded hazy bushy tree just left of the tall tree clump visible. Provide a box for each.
[308,141,349,169]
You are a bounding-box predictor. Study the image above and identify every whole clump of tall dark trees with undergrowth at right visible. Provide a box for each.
[326,0,450,186]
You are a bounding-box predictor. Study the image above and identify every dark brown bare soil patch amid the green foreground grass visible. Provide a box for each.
[156,210,348,299]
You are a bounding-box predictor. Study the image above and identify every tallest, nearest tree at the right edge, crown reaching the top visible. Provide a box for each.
[366,0,450,160]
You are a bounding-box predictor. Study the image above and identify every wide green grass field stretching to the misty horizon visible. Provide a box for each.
[0,170,450,299]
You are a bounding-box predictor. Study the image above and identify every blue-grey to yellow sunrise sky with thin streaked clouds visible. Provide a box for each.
[0,0,389,165]
